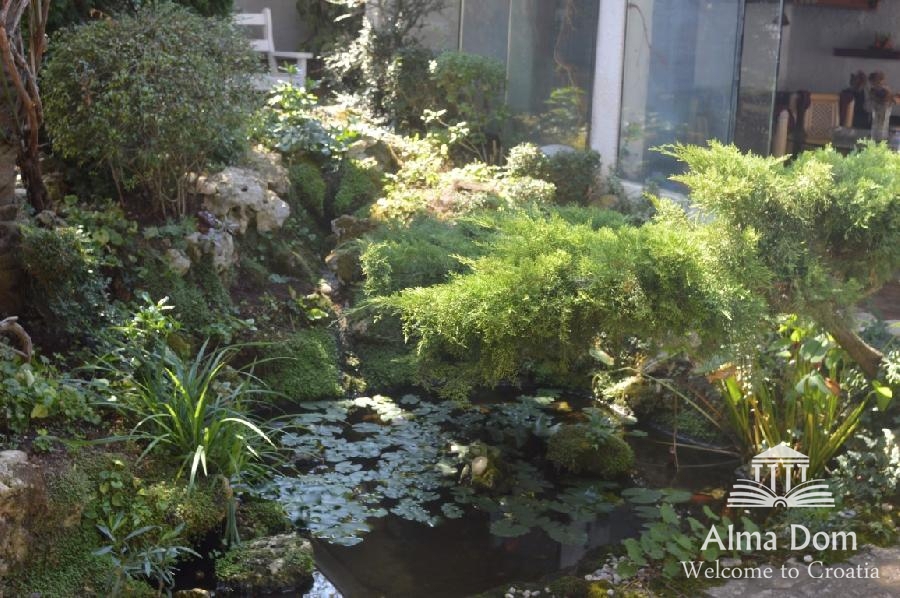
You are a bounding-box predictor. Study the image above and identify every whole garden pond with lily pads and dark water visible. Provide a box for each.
[253,392,738,598]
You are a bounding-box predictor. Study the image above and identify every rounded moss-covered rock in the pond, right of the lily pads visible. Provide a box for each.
[547,424,634,478]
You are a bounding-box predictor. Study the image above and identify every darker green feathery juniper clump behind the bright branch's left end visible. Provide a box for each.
[359,218,490,297]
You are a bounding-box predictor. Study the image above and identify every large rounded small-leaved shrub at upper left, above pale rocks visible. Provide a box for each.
[42,3,257,214]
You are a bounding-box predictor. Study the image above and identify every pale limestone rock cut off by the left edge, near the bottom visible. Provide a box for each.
[0,450,46,578]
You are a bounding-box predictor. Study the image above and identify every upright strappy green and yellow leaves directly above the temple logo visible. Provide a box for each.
[719,316,889,476]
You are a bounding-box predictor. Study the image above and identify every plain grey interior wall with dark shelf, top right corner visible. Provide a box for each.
[779,0,900,93]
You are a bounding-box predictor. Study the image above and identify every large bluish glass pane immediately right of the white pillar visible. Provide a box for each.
[619,0,743,185]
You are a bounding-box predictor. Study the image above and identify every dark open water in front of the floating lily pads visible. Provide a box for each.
[309,510,637,598]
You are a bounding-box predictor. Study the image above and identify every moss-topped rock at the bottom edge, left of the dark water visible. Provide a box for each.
[216,534,313,596]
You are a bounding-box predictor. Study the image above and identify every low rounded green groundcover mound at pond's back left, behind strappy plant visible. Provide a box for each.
[260,328,344,401]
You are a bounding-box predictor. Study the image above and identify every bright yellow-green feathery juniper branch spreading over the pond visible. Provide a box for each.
[375,206,762,396]
